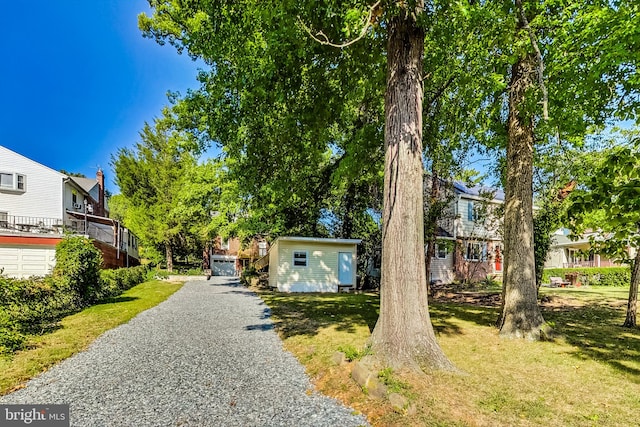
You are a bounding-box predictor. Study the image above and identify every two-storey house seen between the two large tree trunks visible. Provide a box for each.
[425,180,504,283]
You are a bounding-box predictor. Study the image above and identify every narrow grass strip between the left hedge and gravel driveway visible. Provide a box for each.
[0,280,182,395]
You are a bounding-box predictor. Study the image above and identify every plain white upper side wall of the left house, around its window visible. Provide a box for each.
[0,146,64,218]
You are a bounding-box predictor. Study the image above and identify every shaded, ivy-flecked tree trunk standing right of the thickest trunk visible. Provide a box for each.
[498,55,547,340]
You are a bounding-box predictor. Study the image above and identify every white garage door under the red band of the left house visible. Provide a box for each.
[0,247,56,278]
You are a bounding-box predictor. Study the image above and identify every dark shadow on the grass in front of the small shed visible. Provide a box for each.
[259,291,380,338]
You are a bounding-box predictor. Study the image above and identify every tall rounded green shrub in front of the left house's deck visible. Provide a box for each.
[53,236,102,307]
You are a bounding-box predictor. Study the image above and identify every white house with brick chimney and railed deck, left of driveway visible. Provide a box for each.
[0,146,139,277]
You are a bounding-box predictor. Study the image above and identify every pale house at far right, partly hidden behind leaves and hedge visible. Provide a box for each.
[544,229,620,268]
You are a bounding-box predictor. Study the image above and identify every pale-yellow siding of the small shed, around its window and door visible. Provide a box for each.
[269,241,357,292]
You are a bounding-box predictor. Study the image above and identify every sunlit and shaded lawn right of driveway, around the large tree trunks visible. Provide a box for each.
[261,287,640,426]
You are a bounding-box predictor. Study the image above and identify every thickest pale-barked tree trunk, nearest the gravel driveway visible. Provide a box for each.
[371,7,454,371]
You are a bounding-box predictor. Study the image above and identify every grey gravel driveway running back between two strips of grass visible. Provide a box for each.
[0,277,366,427]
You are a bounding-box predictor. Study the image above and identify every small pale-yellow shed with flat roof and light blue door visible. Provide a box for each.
[254,237,361,292]
